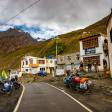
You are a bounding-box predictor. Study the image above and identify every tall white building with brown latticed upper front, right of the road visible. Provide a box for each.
[80,34,109,71]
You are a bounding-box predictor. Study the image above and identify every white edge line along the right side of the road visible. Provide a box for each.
[46,83,93,112]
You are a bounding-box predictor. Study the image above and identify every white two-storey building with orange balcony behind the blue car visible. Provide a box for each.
[21,56,56,74]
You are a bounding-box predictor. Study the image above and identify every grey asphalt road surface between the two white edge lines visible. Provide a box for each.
[18,83,88,112]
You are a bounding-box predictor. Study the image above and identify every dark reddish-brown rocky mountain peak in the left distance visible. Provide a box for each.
[0,28,36,53]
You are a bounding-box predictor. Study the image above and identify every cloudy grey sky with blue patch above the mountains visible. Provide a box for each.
[0,0,112,38]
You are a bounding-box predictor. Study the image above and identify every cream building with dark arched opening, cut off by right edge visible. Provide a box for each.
[107,9,112,78]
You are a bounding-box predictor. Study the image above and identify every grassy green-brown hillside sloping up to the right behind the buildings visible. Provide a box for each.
[0,16,109,69]
